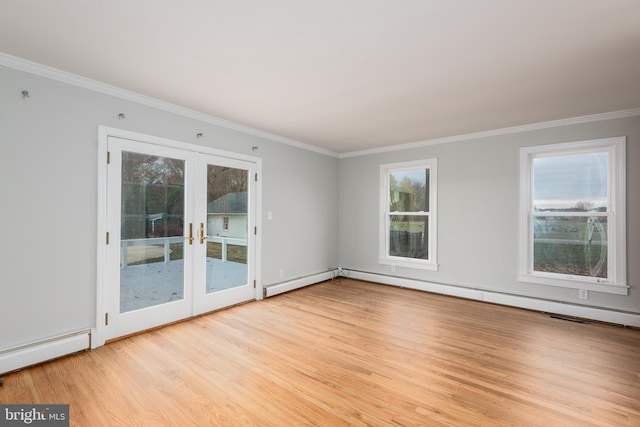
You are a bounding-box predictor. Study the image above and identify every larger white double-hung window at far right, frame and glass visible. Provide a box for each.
[519,137,627,295]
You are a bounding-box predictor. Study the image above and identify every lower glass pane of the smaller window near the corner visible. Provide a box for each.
[389,215,429,259]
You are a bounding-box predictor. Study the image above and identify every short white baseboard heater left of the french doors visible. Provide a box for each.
[0,329,91,374]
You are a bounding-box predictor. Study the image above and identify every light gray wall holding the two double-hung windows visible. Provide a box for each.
[339,116,640,313]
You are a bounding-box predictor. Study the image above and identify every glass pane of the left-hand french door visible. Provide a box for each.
[120,151,185,313]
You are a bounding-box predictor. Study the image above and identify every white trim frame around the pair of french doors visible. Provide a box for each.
[91,126,263,348]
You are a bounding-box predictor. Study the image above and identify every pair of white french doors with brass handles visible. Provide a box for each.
[99,136,256,340]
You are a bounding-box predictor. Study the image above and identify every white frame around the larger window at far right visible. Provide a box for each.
[518,136,628,295]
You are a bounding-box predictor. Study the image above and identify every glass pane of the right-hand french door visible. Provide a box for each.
[206,165,249,293]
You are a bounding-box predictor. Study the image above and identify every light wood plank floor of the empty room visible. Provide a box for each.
[0,279,640,427]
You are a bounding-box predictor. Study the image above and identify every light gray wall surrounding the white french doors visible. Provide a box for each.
[0,66,338,350]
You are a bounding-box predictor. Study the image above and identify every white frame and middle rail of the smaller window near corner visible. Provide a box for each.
[378,159,438,271]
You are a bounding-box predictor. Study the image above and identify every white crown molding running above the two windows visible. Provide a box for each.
[338,108,640,159]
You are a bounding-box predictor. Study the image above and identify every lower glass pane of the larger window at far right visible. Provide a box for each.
[533,216,607,278]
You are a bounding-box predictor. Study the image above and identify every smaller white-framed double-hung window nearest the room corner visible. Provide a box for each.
[379,159,438,270]
